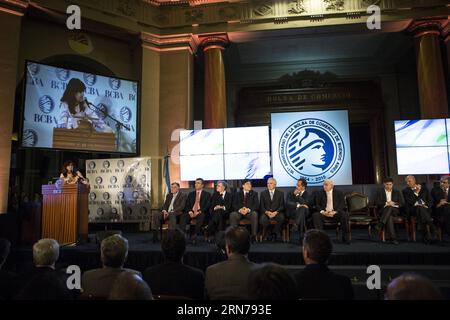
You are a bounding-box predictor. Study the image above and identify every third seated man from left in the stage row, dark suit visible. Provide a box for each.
[208,181,233,237]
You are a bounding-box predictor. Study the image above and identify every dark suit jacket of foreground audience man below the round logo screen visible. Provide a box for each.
[294,264,354,300]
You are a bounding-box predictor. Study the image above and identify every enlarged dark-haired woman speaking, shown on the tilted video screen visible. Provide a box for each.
[58,78,113,132]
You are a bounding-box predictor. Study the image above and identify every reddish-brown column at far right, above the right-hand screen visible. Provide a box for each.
[409,20,449,118]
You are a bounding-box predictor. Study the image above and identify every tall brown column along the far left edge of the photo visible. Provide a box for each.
[0,0,28,214]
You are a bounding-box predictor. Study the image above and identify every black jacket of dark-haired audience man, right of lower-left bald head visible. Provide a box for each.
[144,262,205,300]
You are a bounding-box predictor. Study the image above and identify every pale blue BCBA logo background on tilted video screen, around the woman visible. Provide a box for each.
[22,61,138,153]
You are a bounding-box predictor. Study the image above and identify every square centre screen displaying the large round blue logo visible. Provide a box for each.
[271,110,352,187]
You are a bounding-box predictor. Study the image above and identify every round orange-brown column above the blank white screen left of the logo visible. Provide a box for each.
[199,33,229,128]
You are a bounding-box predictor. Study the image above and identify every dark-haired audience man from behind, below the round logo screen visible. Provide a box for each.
[294,229,354,300]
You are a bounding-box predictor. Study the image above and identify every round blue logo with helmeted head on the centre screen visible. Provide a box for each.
[279,118,345,183]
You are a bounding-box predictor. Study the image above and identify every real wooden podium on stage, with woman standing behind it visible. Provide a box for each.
[42,183,89,244]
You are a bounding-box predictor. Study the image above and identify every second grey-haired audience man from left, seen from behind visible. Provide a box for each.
[81,234,142,299]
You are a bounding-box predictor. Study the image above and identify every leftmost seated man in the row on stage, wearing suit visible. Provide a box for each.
[152,182,186,242]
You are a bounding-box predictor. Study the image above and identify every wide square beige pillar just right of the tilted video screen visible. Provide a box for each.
[140,33,197,202]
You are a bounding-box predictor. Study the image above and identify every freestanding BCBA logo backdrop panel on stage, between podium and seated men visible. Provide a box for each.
[86,157,151,230]
